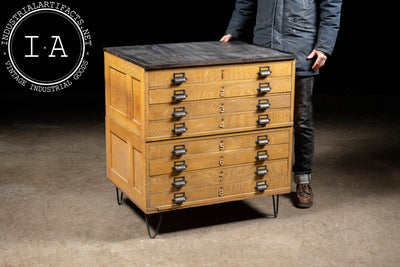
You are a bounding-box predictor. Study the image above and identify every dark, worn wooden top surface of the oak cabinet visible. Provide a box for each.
[104,41,294,70]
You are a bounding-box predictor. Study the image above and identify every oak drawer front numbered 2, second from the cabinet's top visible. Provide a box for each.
[149,77,292,104]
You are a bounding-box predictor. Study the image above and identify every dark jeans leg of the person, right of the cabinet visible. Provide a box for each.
[293,76,314,183]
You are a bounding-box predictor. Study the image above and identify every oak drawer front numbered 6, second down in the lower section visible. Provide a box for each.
[150,144,289,175]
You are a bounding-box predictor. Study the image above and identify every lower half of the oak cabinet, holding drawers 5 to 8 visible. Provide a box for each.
[106,118,292,213]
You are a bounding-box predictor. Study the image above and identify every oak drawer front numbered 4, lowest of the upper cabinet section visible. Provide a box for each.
[148,109,292,139]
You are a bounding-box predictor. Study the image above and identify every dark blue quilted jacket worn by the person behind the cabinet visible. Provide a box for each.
[226,0,342,76]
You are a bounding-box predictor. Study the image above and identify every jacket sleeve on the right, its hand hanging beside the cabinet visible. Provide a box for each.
[314,0,342,55]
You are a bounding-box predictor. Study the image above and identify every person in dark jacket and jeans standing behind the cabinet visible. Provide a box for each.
[220,0,342,208]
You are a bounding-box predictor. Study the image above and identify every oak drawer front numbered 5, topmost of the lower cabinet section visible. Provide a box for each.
[148,129,291,160]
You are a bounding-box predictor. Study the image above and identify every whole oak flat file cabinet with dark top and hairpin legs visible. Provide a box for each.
[104,42,295,238]
